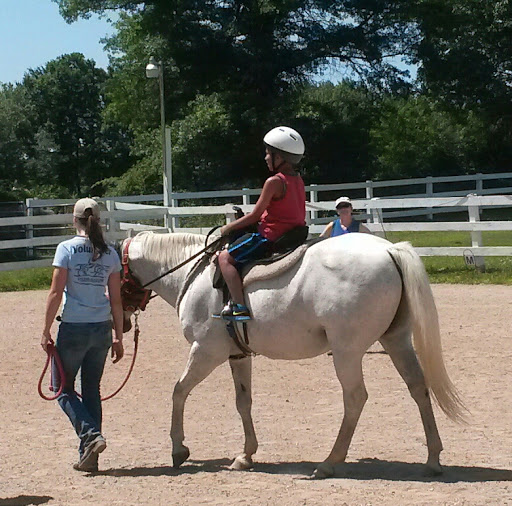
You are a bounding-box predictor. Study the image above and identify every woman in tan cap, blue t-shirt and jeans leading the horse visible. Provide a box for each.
[41,198,124,472]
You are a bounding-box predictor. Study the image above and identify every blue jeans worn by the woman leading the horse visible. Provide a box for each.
[55,321,112,456]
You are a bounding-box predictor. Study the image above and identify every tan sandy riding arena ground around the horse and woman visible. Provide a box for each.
[0,285,512,506]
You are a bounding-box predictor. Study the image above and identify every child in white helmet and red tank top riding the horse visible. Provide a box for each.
[215,126,306,321]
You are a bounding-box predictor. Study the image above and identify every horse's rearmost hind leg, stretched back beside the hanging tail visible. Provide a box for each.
[380,328,443,475]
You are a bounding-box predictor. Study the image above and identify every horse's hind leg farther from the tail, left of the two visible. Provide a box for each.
[312,347,368,478]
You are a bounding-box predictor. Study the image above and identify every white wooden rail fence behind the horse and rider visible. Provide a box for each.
[0,173,512,271]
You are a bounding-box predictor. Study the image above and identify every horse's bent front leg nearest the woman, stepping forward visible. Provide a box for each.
[171,342,227,468]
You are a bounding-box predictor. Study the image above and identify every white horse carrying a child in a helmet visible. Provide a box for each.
[122,233,465,478]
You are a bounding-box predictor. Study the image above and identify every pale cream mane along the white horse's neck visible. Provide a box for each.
[134,231,205,266]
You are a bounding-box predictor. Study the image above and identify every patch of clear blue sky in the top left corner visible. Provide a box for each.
[0,0,114,84]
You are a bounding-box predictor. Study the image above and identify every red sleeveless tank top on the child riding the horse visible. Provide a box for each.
[258,172,306,241]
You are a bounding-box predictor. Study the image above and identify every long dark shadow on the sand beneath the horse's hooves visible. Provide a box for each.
[94,459,512,482]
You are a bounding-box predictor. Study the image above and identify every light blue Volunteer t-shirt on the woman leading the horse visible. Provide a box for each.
[53,236,121,323]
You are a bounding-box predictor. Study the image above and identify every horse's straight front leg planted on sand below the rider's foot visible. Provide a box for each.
[229,357,258,470]
